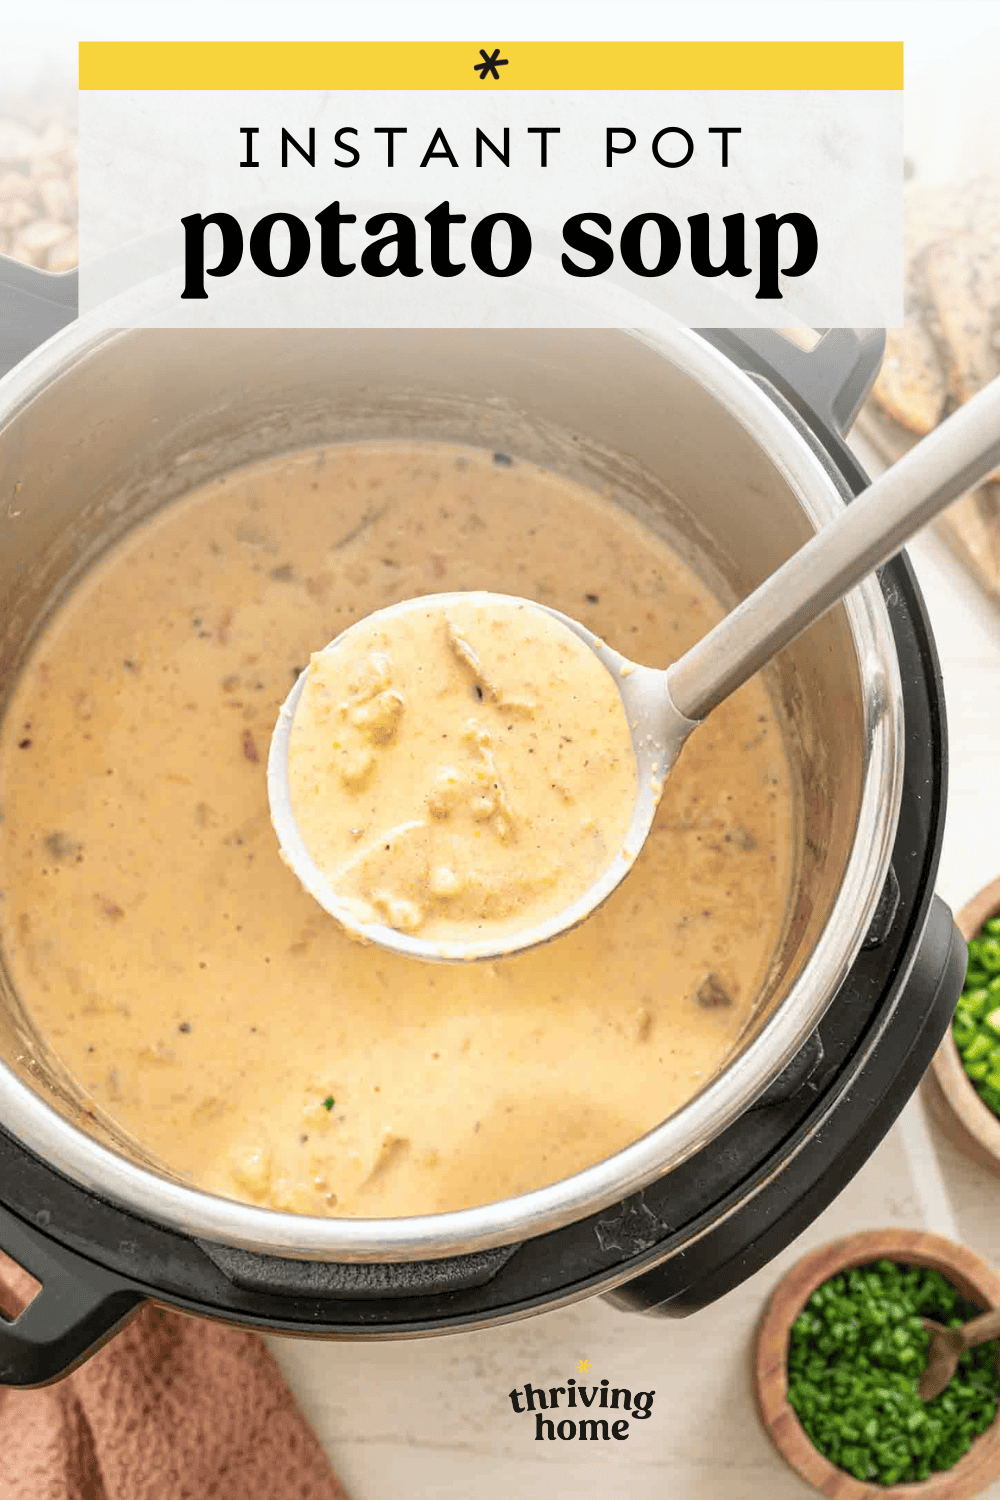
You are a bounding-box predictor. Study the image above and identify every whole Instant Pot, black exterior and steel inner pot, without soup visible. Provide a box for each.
[0,263,966,1385]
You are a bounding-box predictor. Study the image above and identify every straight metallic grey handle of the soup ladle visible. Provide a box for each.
[667,380,1000,720]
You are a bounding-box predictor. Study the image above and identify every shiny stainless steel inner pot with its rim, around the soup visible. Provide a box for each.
[0,320,903,1262]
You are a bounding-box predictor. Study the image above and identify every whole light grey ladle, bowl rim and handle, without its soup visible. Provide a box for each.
[267,380,1000,962]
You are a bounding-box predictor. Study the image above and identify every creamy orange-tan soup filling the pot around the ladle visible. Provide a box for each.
[0,444,795,1217]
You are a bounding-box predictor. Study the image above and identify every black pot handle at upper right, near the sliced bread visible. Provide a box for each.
[699,329,886,438]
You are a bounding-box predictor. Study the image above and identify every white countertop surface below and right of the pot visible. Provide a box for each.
[270,450,1000,1500]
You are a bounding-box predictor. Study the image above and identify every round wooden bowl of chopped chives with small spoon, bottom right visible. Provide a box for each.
[753,1229,1000,1500]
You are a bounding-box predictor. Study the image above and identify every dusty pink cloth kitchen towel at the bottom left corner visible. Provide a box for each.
[0,1257,346,1500]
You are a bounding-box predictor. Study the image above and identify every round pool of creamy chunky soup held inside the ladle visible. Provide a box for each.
[288,594,637,942]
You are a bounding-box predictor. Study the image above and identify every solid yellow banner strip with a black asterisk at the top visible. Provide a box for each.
[79,42,903,93]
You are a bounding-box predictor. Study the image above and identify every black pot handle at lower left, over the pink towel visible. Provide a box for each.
[0,1206,145,1386]
